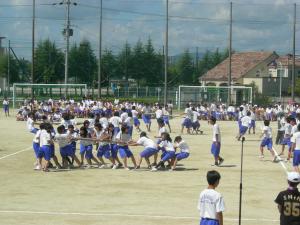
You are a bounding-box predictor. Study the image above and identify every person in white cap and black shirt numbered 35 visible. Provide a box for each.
[275,172,300,225]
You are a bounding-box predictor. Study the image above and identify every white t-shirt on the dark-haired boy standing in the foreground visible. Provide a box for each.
[198,189,225,219]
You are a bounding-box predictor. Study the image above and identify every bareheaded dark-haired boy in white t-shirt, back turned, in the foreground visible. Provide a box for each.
[198,170,225,225]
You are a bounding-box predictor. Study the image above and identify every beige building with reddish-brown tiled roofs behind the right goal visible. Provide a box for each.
[199,51,300,97]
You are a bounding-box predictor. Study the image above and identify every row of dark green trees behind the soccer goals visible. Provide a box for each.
[0,39,228,87]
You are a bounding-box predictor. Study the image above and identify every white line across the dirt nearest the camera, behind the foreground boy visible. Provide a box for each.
[0,210,279,222]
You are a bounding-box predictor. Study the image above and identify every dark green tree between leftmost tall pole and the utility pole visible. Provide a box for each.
[34,39,64,84]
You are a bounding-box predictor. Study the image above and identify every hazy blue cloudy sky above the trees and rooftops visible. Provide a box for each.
[0,0,300,58]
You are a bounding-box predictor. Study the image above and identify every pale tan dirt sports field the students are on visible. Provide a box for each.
[0,111,291,225]
